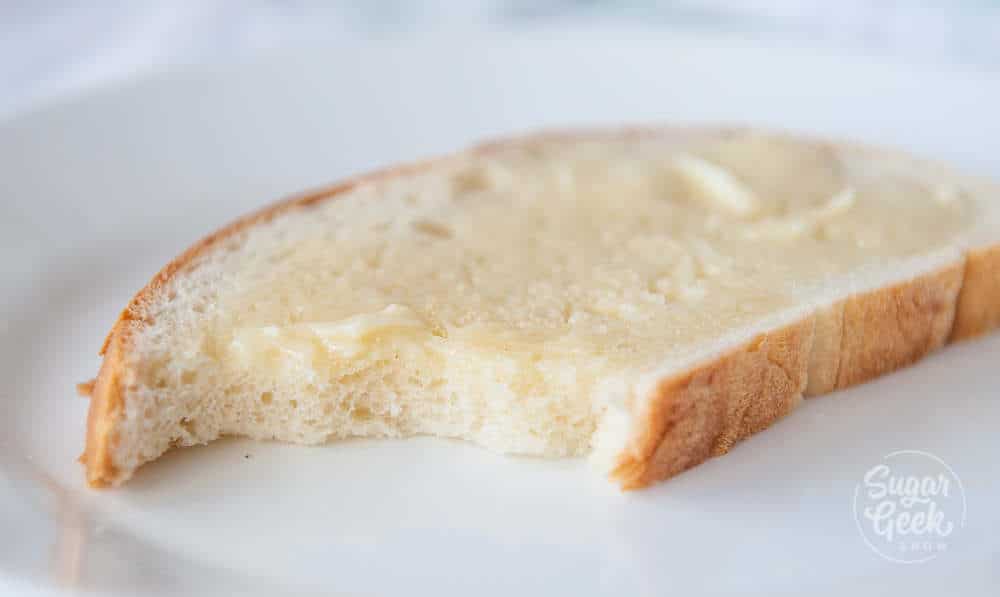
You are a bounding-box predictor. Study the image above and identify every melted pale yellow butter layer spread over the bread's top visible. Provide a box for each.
[218,135,974,372]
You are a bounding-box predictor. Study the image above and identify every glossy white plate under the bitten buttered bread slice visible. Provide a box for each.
[0,31,1000,595]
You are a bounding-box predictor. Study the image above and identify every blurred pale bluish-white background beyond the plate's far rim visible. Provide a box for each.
[0,0,1000,117]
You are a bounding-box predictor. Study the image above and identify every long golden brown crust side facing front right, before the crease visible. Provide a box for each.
[611,260,988,489]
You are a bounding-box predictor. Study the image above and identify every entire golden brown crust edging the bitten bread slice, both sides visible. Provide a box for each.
[80,127,1000,489]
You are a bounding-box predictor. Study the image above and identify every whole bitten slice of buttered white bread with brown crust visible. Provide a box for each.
[81,128,1000,489]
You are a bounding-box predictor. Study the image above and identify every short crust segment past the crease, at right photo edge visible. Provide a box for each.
[951,244,1000,341]
